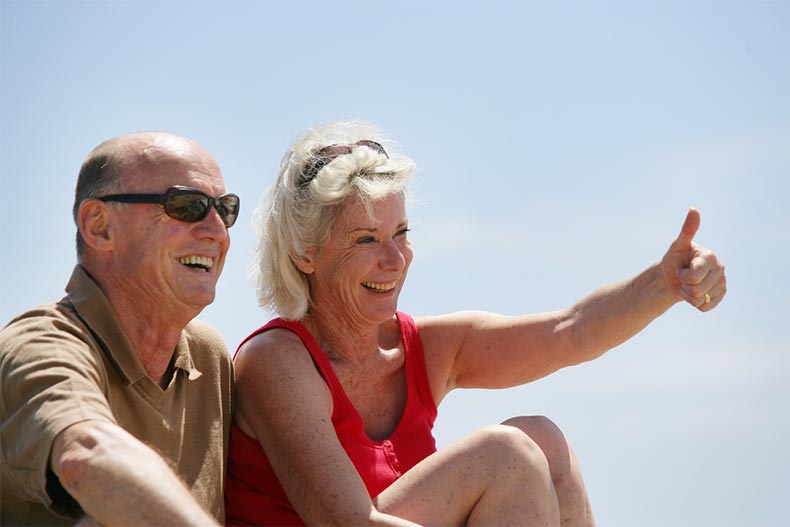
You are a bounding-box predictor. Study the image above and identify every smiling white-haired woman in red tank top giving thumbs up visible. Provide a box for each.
[226,123,726,525]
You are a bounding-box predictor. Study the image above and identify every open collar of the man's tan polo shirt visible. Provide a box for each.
[66,264,201,384]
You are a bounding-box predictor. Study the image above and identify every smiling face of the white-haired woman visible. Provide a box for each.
[306,194,413,324]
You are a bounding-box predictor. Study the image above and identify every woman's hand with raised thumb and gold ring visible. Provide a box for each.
[661,208,727,311]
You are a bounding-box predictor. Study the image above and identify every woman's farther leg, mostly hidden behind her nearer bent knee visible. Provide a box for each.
[502,416,595,527]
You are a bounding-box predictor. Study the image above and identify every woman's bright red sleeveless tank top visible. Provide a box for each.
[225,312,436,525]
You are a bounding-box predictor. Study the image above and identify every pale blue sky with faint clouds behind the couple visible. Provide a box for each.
[0,0,790,527]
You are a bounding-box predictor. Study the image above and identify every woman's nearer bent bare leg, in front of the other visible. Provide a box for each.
[375,425,560,526]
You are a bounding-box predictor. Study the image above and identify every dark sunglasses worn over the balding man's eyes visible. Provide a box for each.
[96,185,239,228]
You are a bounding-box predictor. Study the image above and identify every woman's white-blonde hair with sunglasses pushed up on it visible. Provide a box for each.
[253,122,416,320]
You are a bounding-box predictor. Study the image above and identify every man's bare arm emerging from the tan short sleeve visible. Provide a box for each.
[50,421,218,526]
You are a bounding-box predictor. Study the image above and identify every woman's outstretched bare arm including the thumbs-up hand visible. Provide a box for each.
[417,209,727,402]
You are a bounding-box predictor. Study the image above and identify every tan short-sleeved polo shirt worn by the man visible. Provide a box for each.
[0,266,233,525]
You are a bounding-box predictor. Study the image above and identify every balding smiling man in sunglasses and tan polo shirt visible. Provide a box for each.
[0,133,239,525]
